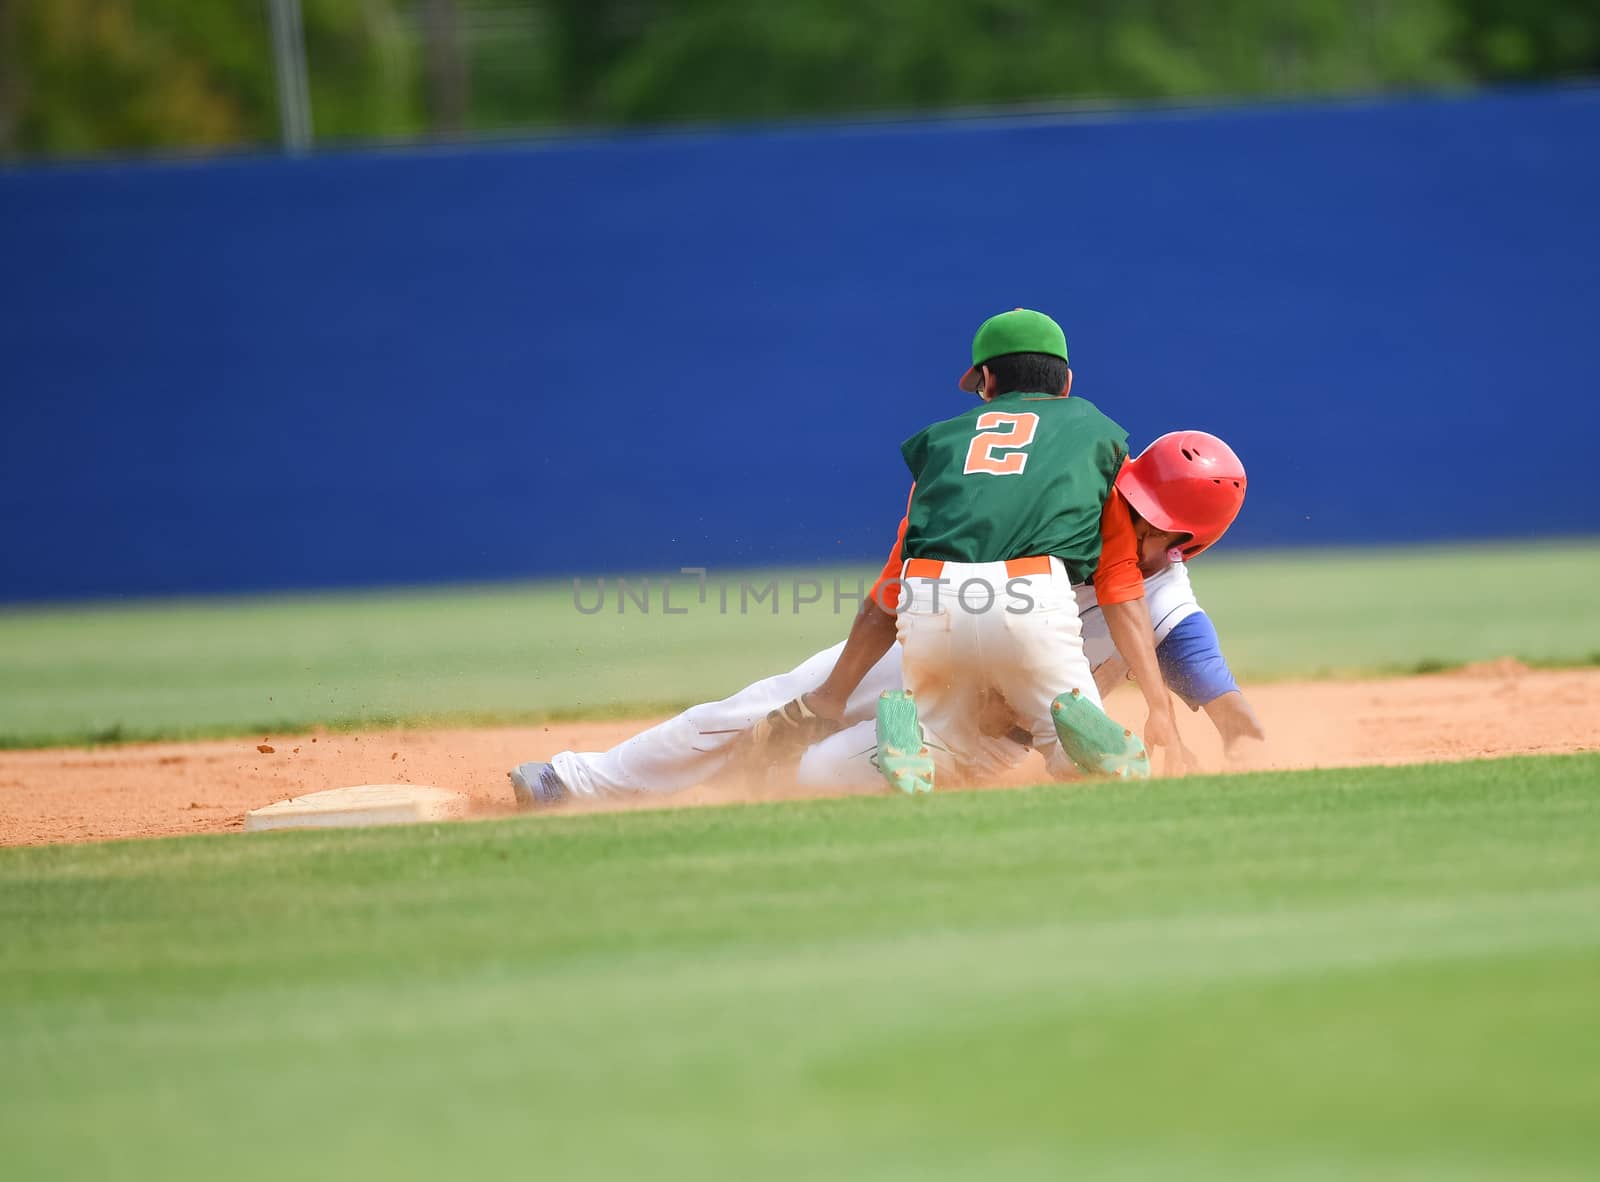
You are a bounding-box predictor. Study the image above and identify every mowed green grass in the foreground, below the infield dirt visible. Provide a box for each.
[0,755,1600,1182]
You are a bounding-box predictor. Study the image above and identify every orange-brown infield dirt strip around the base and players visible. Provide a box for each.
[0,661,1600,845]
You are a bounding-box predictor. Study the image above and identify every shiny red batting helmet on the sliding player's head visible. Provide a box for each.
[1117,430,1246,561]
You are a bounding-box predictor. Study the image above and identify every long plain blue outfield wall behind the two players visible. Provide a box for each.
[0,90,1600,600]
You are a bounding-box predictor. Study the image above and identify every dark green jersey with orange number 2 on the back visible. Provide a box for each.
[901,392,1128,582]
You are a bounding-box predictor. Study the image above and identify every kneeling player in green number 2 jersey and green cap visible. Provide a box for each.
[755,309,1178,792]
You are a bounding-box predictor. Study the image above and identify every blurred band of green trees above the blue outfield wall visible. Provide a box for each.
[0,0,1600,155]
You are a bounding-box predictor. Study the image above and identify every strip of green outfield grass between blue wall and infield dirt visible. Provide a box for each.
[0,541,1600,747]
